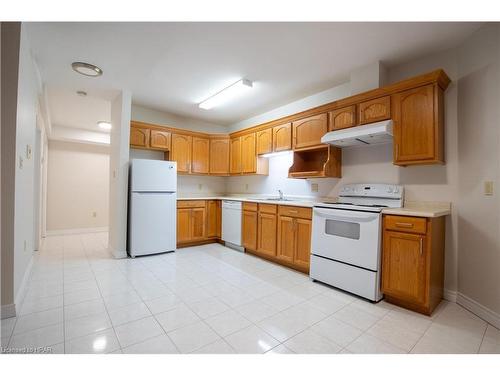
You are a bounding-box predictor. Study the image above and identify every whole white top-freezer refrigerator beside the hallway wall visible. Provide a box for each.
[128,159,177,258]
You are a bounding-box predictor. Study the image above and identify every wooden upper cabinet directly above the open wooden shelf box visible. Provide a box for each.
[293,113,328,150]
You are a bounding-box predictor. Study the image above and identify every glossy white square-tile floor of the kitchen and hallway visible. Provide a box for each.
[2,233,500,353]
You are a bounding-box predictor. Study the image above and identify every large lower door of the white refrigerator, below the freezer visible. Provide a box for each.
[129,192,177,256]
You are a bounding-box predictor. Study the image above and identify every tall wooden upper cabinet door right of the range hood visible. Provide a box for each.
[393,85,439,165]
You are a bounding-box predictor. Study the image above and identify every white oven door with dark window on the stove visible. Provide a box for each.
[311,207,381,271]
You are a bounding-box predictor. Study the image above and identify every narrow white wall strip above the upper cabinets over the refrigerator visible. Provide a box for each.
[130,104,227,133]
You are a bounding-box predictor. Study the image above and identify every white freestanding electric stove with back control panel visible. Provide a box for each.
[310,184,404,301]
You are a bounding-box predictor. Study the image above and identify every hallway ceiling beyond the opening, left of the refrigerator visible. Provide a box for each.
[47,87,111,133]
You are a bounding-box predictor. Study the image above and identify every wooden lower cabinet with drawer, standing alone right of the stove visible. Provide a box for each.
[382,215,445,315]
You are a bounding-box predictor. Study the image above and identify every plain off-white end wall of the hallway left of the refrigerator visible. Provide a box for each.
[47,140,109,231]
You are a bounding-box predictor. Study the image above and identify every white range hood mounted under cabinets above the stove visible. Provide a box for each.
[321,120,392,147]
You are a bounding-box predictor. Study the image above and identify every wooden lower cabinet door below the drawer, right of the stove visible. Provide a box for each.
[382,230,427,304]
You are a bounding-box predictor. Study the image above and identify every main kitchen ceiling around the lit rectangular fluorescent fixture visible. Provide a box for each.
[28,23,480,126]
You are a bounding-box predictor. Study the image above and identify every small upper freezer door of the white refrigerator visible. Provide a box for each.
[130,159,177,192]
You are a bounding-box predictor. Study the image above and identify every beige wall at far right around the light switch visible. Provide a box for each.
[457,23,500,318]
